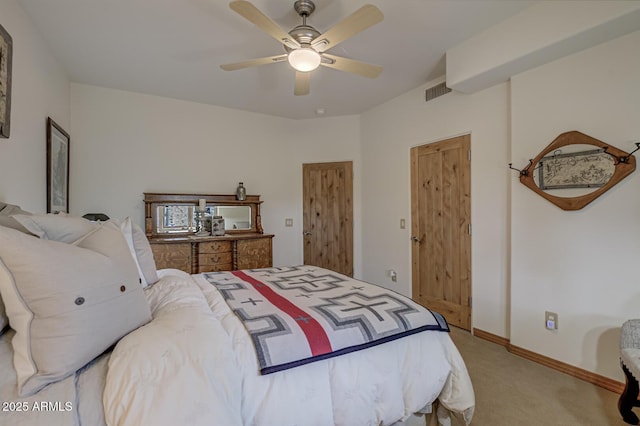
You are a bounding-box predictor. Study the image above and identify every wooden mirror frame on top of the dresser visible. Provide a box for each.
[143,192,264,238]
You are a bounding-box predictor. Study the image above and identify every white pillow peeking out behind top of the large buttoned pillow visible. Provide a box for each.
[13,214,99,243]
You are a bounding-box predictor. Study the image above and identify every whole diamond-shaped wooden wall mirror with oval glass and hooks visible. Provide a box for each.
[509,131,640,210]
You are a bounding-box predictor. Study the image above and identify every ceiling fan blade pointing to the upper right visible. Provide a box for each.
[311,4,384,52]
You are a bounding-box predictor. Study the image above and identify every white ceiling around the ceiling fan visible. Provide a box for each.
[14,0,536,119]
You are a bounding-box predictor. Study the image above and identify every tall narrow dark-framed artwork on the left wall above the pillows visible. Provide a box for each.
[47,117,70,213]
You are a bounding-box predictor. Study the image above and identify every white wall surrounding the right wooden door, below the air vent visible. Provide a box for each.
[362,75,509,336]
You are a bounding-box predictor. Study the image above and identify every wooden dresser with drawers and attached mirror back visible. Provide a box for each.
[144,193,273,274]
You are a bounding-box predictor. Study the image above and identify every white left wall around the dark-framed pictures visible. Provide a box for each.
[0,0,69,212]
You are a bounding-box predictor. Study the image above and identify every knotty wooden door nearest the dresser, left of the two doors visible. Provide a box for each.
[302,161,353,276]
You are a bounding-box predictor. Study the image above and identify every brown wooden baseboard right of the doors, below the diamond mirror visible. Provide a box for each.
[473,328,624,394]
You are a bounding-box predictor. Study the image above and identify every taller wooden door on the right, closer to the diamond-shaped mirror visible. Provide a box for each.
[411,135,471,330]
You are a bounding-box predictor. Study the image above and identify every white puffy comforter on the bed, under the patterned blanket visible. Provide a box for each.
[103,271,474,426]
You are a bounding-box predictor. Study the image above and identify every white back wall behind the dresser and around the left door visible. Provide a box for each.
[70,84,361,275]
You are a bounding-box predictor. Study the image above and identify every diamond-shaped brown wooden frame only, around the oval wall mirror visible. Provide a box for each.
[510,130,636,210]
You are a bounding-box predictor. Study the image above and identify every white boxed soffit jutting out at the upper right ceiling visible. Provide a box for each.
[446,0,640,93]
